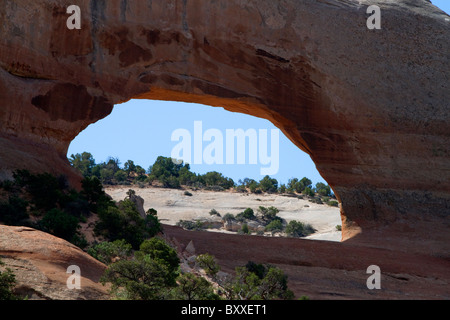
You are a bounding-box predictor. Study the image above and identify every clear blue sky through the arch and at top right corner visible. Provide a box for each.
[68,0,450,183]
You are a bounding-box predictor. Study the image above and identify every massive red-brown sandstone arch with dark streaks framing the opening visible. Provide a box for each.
[0,0,450,250]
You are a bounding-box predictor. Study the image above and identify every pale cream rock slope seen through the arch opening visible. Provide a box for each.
[105,186,342,241]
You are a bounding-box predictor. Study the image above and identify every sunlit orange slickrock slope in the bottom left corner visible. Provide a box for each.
[0,225,109,300]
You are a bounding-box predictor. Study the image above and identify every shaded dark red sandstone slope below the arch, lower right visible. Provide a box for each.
[164,226,450,300]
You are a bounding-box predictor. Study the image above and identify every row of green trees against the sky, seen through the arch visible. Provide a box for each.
[69,152,337,205]
